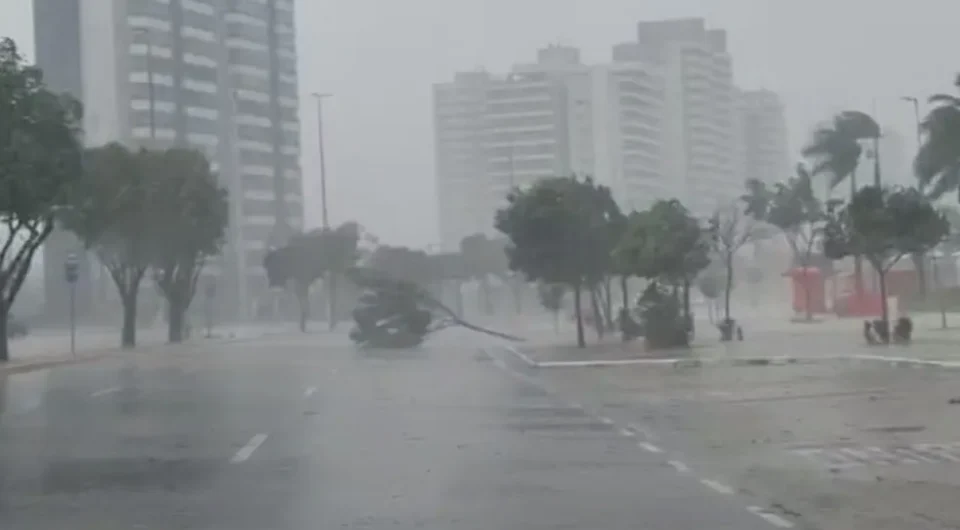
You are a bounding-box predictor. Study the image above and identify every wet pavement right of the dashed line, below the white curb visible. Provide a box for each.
[518,351,960,530]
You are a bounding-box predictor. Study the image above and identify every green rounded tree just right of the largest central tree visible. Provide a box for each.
[614,199,710,320]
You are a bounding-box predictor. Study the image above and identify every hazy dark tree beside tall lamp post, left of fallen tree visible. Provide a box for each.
[263,221,362,331]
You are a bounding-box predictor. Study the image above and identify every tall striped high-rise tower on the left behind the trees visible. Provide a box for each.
[34,0,303,318]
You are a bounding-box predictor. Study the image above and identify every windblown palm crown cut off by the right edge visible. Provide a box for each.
[913,74,960,201]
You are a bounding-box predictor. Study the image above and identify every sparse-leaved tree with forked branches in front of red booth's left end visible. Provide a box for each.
[741,164,826,320]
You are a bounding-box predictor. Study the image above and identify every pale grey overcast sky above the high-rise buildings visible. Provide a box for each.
[0,0,960,245]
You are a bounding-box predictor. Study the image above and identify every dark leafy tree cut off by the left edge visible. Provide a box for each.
[0,39,82,362]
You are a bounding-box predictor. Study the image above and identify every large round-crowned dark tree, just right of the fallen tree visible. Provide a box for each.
[496,177,617,348]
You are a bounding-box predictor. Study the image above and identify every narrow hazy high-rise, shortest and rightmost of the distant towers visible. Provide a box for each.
[739,90,793,183]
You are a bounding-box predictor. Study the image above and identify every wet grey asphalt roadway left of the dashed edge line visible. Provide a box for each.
[0,331,774,530]
